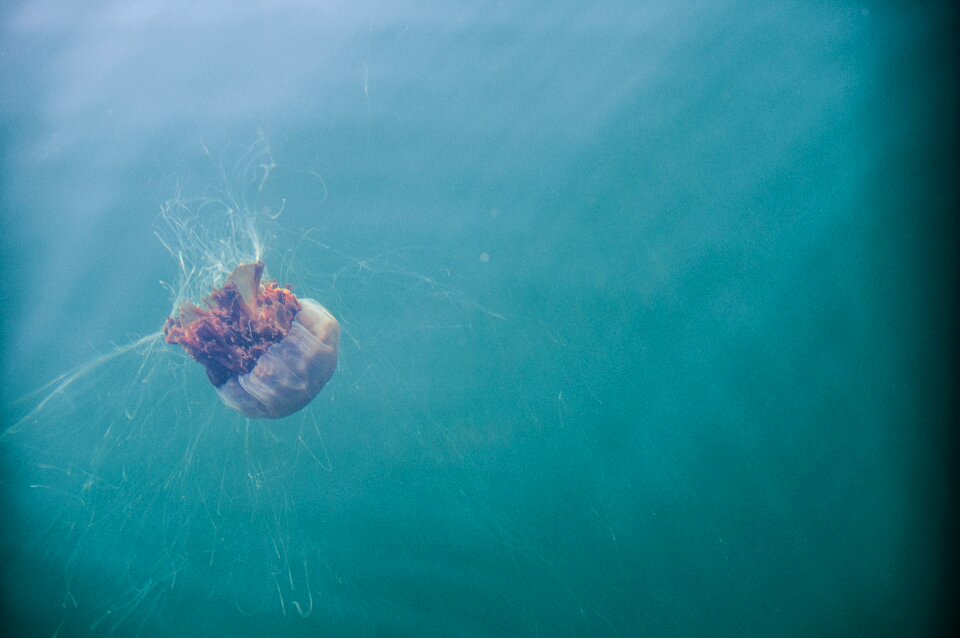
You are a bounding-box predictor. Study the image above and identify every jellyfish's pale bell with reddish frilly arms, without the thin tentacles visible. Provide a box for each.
[164,261,340,419]
